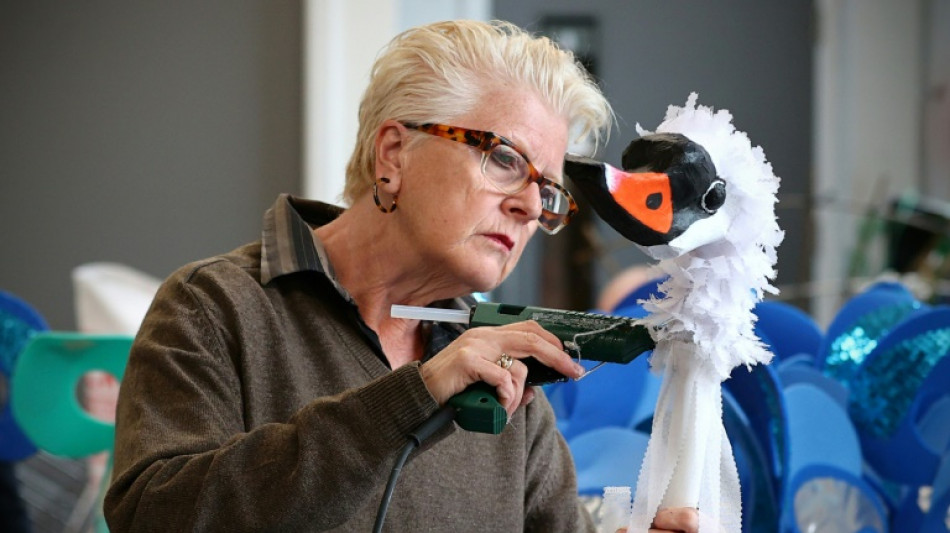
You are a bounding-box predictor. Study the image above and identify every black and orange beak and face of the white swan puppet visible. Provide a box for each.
[564,133,726,247]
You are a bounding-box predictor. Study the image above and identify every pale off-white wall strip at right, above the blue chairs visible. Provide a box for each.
[811,0,926,323]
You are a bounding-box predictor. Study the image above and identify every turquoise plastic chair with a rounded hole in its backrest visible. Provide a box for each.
[11,332,132,533]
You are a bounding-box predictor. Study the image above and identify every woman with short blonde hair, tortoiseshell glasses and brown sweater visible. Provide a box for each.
[105,18,691,532]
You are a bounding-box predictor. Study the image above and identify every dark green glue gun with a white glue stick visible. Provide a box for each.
[391,302,656,435]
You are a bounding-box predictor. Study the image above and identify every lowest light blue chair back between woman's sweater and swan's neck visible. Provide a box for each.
[568,427,650,496]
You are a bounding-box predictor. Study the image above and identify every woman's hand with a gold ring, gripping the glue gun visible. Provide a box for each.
[422,320,584,417]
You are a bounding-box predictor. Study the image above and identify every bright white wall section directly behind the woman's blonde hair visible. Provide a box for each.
[303,0,491,204]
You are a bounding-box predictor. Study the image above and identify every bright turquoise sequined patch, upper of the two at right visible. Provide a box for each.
[824,301,921,385]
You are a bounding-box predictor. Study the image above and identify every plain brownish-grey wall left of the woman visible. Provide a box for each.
[0,0,301,329]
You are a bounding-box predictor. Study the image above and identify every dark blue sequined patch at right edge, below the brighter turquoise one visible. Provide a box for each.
[848,327,950,437]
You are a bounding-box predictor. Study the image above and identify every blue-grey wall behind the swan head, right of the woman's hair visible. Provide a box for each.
[494,0,812,303]
